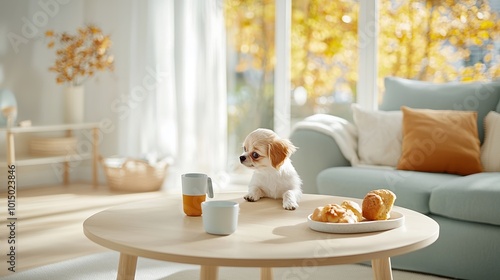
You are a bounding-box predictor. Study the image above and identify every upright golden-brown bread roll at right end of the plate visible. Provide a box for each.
[362,189,396,221]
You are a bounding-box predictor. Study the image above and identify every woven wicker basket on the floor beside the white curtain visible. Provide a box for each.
[101,157,168,192]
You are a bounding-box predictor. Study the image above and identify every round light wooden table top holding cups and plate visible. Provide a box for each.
[83,193,439,267]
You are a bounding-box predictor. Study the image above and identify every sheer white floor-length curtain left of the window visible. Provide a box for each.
[117,0,227,188]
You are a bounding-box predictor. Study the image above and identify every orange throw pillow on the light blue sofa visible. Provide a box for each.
[397,106,483,175]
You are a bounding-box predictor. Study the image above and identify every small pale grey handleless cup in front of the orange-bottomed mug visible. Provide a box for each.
[201,200,240,235]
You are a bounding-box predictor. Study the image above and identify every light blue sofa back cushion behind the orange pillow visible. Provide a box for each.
[379,77,500,142]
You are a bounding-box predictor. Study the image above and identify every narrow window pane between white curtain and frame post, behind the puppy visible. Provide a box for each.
[225,0,275,173]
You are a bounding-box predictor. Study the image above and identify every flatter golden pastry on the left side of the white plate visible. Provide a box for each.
[311,201,362,224]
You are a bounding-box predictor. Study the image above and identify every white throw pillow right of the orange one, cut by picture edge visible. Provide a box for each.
[481,111,500,172]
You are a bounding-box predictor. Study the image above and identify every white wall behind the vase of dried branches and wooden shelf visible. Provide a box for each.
[0,0,134,188]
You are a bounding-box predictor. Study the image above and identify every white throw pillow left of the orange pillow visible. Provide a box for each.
[352,104,403,167]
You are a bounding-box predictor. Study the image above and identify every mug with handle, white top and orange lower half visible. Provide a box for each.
[181,173,214,216]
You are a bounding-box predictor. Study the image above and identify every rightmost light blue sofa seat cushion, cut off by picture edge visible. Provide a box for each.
[429,172,500,225]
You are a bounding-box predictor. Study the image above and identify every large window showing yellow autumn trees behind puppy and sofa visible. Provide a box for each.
[225,0,500,177]
